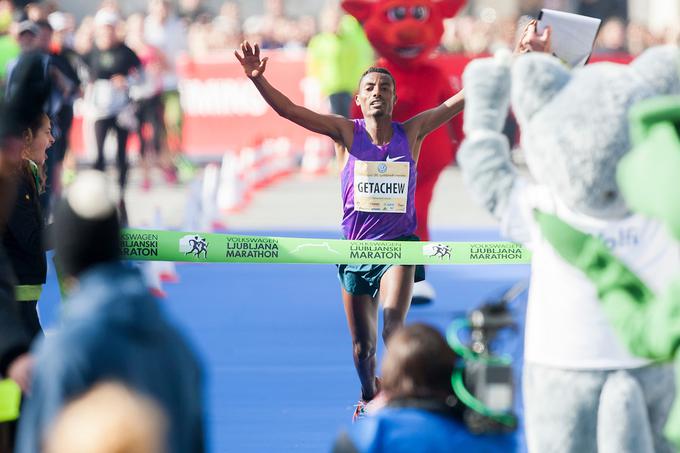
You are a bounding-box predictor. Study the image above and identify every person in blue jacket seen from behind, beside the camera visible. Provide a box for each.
[333,323,517,453]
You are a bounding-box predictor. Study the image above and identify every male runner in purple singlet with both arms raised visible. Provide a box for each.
[234,41,464,419]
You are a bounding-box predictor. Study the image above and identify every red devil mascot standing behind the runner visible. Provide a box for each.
[342,0,465,303]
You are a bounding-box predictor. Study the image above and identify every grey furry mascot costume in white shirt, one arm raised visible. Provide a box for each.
[458,48,680,453]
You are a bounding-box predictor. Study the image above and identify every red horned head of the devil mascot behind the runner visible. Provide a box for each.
[342,0,465,66]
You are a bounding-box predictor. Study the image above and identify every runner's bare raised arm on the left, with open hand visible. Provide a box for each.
[234,41,354,148]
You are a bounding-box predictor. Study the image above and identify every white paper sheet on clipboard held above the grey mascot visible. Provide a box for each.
[536,9,602,67]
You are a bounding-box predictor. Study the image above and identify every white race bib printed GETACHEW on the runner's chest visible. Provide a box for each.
[354,161,410,213]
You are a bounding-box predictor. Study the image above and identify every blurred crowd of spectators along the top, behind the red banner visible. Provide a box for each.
[0,0,680,113]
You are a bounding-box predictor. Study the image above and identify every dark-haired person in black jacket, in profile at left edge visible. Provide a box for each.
[2,113,54,338]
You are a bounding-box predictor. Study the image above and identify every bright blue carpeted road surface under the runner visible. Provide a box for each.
[40,229,529,453]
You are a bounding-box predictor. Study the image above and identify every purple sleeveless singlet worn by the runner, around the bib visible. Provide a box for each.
[340,119,416,240]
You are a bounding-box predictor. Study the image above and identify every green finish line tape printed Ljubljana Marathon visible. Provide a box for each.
[121,229,531,265]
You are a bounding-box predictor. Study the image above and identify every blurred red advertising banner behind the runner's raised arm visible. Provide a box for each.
[71,52,632,159]
